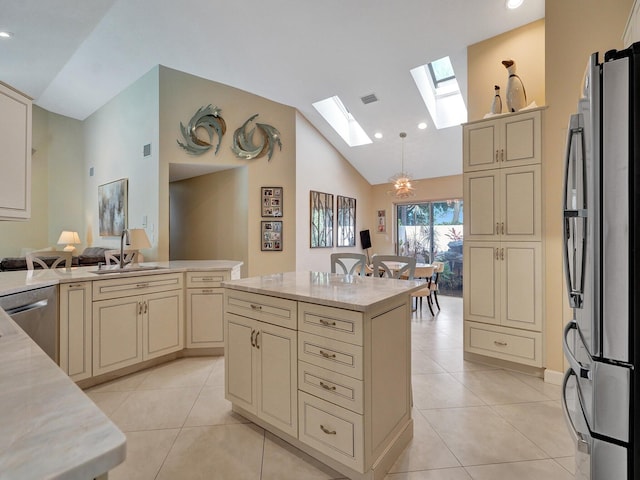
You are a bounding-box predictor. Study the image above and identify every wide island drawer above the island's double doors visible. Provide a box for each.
[224,288,298,330]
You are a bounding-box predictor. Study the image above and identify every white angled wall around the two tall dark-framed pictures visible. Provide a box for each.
[296,113,375,272]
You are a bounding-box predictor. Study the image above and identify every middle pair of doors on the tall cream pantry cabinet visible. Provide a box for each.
[464,165,542,241]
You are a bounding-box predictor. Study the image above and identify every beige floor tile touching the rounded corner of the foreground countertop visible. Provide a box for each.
[109,428,180,480]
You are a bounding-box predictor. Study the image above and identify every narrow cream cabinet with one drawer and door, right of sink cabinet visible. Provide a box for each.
[185,267,240,348]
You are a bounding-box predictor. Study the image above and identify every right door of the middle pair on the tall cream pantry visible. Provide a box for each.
[500,165,542,241]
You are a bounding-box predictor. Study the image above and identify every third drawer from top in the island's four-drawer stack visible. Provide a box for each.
[298,362,364,414]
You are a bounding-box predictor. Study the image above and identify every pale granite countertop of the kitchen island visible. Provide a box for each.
[222,272,425,312]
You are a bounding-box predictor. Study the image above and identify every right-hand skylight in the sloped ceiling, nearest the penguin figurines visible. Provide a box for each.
[411,57,467,129]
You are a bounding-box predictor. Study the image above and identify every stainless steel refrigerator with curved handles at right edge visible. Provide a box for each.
[563,43,640,480]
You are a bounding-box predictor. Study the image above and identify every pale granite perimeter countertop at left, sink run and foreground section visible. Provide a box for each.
[0,260,242,480]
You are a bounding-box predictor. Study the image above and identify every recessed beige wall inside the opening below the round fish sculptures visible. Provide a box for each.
[169,167,249,277]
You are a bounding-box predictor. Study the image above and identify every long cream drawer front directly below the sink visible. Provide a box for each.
[93,273,184,302]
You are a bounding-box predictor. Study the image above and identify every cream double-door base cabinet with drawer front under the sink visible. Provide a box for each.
[93,274,184,375]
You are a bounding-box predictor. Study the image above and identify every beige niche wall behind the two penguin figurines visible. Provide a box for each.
[467,19,545,121]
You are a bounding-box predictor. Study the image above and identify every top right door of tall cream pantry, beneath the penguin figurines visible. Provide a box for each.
[498,111,542,167]
